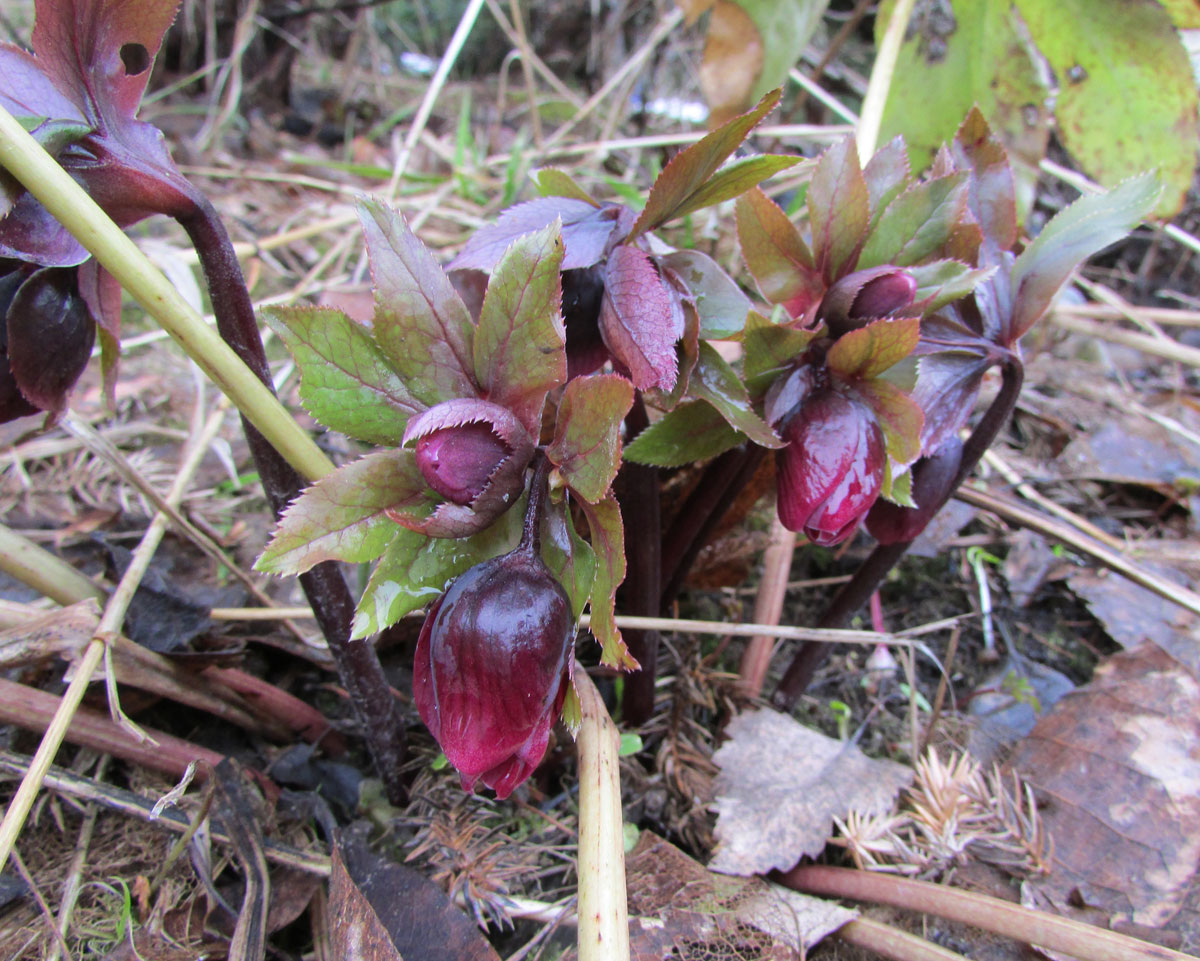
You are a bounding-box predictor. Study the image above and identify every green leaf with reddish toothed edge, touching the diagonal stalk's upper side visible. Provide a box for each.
[263,307,425,446]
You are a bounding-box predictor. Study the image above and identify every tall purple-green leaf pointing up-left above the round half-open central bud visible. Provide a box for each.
[359,200,479,407]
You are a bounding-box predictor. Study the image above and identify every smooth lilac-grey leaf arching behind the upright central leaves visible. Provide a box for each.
[446,197,623,274]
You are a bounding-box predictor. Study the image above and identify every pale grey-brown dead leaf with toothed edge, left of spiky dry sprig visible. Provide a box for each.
[712,710,912,875]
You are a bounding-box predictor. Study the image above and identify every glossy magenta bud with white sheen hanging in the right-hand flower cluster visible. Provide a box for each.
[775,388,887,547]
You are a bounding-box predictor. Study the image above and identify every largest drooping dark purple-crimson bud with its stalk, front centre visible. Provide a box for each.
[413,458,575,798]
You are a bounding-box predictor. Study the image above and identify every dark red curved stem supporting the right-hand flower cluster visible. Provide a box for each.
[772,352,1025,710]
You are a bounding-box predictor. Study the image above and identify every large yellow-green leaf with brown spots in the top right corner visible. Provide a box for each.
[1016,0,1198,217]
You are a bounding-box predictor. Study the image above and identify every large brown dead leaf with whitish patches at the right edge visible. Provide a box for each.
[1012,643,1200,927]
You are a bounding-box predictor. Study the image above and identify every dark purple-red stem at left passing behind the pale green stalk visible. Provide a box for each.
[178,194,406,804]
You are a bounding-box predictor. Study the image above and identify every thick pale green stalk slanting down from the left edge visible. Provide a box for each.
[0,101,334,480]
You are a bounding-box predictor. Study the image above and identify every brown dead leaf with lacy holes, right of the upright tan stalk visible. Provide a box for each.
[625,831,858,961]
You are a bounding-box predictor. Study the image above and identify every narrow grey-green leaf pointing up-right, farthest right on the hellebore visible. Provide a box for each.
[1008,173,1162,343]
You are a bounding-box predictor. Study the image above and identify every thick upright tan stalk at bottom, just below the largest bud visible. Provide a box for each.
[575,666,629,961]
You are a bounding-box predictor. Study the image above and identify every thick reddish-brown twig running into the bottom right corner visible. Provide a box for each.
[779,865,1195,961]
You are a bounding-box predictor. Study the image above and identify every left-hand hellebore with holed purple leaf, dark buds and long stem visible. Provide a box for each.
[0,0,403,801]
